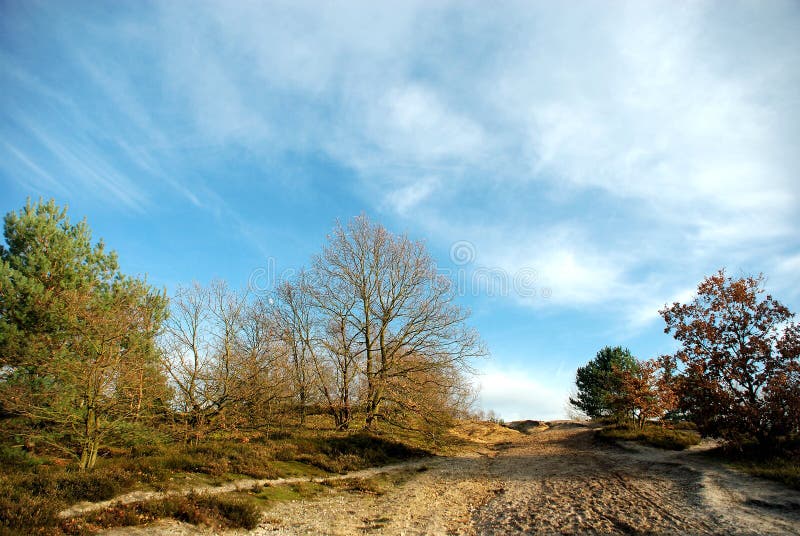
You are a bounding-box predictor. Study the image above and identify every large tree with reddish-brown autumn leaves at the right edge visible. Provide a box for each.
[660,270,800,444]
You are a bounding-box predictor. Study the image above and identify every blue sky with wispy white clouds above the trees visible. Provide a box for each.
[0,0,800,419]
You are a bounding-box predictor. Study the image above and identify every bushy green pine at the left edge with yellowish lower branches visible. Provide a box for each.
[0,200,167,469]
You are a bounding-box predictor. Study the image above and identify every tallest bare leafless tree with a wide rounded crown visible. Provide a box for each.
[314,216,485,427]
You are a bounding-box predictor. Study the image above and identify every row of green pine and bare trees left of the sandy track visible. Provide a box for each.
[0,200,485,469]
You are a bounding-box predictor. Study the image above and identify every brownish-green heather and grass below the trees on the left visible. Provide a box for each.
[0,421,430,534]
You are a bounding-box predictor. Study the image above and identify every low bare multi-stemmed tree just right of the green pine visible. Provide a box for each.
[164,281,285,442]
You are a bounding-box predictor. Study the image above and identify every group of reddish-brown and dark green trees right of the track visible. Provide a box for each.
[570,270,800,448]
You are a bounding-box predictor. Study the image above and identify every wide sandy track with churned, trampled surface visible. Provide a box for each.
[98,422,800,535]
